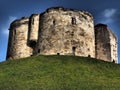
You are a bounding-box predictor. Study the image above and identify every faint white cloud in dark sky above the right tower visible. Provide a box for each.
[101,8,117,24]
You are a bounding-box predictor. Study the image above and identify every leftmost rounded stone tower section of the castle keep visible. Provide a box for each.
[7,18,32,59]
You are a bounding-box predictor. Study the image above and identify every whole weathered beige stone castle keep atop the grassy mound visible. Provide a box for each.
[7,7,117,63]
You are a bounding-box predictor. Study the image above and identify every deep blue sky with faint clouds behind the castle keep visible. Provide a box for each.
[0,0,120,62]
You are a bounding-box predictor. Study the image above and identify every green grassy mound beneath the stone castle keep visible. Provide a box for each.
[0,56,120,90]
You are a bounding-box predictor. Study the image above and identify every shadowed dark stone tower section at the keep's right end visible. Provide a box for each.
[95,24,118,63]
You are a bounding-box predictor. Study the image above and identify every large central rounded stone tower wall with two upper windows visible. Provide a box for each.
[37,8,95,57]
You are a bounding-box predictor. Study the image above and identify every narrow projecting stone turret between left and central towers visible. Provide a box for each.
[28,14,40,55]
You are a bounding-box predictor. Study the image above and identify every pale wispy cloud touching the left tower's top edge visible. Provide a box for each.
[2,16,17,36]
